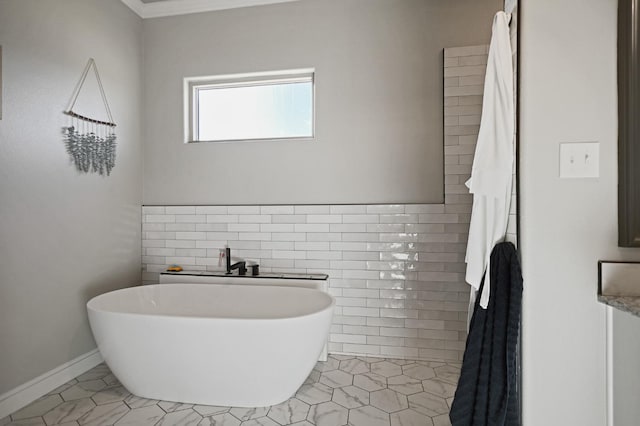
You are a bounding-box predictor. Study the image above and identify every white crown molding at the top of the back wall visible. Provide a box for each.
[122,0,299,19]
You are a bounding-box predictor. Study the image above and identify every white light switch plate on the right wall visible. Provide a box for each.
[560,142,600,179]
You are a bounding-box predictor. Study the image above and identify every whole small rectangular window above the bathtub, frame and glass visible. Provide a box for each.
[184,70,314,142]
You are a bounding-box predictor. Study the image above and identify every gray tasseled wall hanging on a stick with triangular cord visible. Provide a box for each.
[62,58,116,176]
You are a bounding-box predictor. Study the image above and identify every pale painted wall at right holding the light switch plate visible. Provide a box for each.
[519,0,640,426]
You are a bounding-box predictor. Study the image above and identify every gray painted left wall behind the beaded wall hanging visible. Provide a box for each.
[0,0,142,394]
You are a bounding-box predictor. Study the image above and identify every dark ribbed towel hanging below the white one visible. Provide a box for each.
[449,243,522,426]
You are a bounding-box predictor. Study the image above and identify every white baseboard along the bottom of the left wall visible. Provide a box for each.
[0,349,103,419]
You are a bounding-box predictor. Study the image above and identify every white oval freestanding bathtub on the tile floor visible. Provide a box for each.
[87,283,334,407]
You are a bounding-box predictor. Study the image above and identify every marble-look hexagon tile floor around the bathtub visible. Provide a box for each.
[0,355,460,426]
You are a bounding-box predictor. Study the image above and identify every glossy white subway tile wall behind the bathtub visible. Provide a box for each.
[142,46,515,361]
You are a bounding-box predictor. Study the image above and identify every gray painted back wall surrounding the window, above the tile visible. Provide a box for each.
[143,0,502,205]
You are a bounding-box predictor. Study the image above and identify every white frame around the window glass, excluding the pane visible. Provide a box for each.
[183,68,316,143]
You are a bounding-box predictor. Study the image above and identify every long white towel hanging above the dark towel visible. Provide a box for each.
[465,12,515,309]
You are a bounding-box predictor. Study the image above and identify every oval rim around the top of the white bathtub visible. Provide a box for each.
[86,283,336,322]
